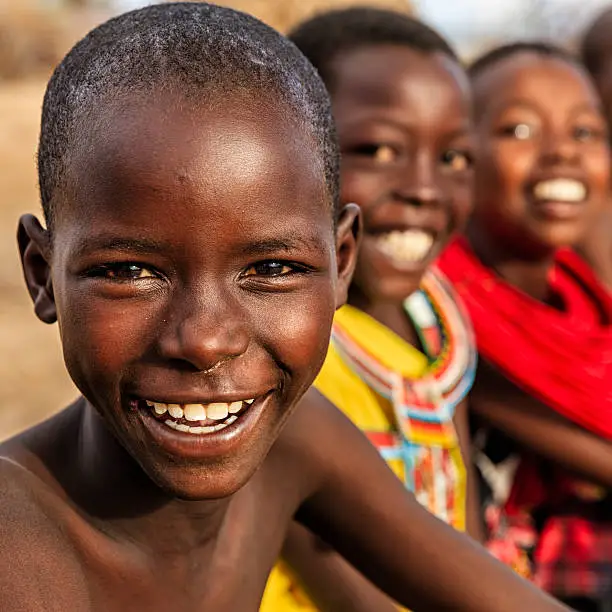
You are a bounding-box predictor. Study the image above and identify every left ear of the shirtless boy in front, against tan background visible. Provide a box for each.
[17,215,57,323]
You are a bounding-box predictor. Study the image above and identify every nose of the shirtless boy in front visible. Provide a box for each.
[159,292,250,372]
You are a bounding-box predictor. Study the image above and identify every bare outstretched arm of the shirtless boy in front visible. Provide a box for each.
[287,391,567,612]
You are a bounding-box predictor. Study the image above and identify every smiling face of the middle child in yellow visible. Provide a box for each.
[332,46,472,302]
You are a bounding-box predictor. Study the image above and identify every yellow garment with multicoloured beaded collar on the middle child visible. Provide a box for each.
[261,267,476,611]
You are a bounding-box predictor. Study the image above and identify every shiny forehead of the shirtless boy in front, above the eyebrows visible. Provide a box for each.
[58,92,331,232]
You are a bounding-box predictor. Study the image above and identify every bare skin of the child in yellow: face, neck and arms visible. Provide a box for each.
[284,45,481,612]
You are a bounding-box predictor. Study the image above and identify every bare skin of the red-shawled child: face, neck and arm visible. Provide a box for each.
[467,53,612,486]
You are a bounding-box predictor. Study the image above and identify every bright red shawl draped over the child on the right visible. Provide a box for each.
[438,238,612,439]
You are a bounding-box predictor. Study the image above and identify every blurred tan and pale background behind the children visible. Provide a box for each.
[0,0,610,439]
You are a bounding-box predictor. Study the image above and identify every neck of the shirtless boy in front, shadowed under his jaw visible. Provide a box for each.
[60,399,233,555]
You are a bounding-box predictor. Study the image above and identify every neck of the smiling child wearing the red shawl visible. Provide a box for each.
[465,220,555,302]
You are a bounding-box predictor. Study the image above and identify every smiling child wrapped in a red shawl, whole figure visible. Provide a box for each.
[439,44,612,610]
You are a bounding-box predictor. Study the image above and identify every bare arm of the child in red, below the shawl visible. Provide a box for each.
[470,360,612,488]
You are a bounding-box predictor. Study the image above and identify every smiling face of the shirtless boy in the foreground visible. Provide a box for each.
[22,97,356,499]
